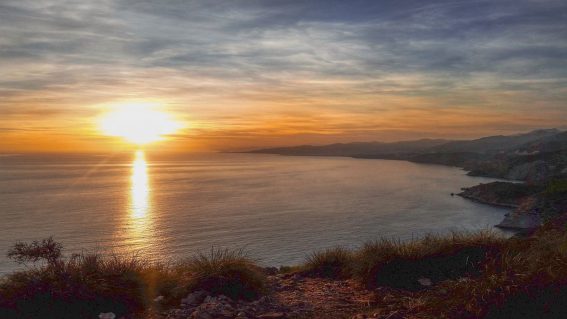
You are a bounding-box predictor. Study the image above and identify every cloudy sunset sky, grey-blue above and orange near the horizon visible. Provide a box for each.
[0,0,567,153]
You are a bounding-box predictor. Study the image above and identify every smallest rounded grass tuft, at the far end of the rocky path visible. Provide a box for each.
[302,247,353,278]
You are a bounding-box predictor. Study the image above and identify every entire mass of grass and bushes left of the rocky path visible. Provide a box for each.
[0,238,265,319]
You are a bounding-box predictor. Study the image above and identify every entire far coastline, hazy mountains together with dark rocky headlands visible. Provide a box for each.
[247,128,567,230]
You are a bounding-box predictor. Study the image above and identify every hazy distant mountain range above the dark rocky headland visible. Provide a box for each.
[248,129,567,183]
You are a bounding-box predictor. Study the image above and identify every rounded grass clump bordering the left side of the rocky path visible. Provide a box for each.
[183,249,266,300]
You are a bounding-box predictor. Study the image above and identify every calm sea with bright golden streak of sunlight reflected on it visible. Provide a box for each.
[0,152,506,273]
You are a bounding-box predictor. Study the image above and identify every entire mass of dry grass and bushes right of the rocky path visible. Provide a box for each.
[303,231,567,319]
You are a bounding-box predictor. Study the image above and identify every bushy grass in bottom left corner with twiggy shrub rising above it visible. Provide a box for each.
[0,238,173,318]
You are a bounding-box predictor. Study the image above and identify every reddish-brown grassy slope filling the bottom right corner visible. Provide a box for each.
[384,232,567,319]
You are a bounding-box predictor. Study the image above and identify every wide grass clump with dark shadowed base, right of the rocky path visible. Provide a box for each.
[353,231,505,290]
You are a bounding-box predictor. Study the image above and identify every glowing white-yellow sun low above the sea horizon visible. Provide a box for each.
[99,103,181,145]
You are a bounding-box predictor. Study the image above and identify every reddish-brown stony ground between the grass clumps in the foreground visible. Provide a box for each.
[165,274,384,319]
